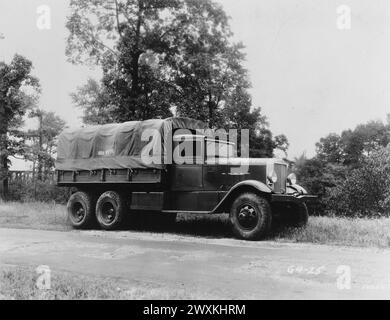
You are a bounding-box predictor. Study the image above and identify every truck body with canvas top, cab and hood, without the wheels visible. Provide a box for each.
[57,118,315,240]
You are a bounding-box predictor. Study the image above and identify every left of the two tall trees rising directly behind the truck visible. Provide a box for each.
[67,0,186,121]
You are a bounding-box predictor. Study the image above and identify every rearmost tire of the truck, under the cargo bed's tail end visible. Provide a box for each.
[67,192,96,229]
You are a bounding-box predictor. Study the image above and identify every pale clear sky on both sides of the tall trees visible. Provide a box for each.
[0,0,390,170]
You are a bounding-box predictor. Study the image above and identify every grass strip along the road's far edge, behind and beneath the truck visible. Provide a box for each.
[0,202,390,248]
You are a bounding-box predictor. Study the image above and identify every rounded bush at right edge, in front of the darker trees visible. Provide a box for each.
[328,148,390,217]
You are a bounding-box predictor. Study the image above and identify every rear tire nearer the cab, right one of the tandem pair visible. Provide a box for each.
[96,191,128,230]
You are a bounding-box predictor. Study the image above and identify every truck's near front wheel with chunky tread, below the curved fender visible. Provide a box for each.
[230,193,272,240]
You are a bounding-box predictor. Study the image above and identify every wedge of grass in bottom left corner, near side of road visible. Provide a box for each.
[0,266,218,300]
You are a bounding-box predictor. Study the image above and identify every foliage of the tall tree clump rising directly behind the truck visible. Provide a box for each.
[67,0,288,157]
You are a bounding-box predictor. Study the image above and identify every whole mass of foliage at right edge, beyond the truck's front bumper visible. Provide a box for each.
[295,117,390,217]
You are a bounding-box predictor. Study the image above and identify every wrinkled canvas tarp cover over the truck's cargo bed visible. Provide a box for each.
[56,118,207,171]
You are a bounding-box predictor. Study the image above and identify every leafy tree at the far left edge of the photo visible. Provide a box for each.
[0,55,39,198]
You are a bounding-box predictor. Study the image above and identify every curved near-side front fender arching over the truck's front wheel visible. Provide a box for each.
[211,180,272,213]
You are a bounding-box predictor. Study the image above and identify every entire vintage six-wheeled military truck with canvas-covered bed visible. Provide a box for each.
[56,118,315,240]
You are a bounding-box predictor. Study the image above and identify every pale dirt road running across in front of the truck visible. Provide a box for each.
[0,229,390,299]
